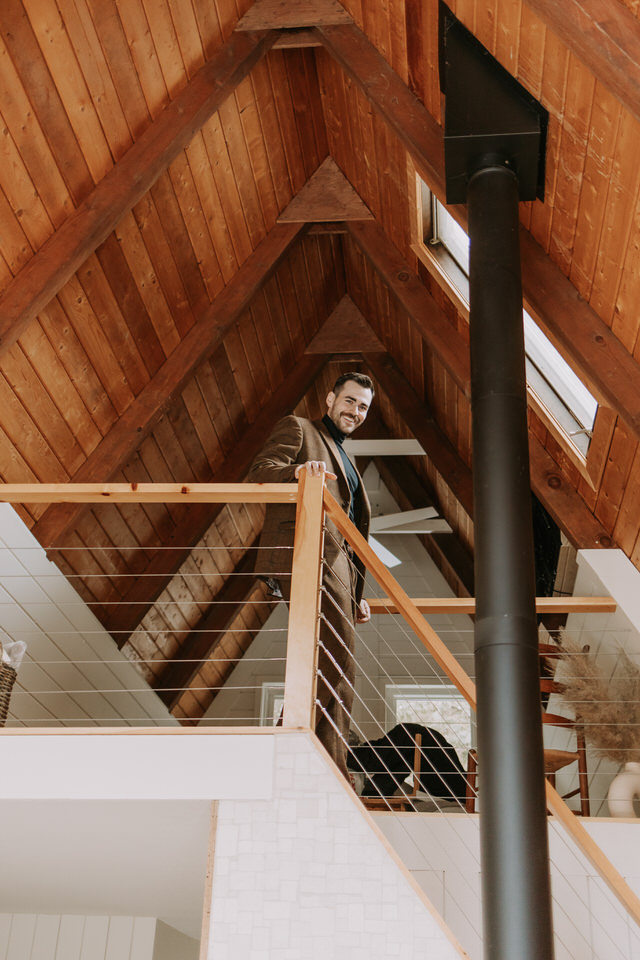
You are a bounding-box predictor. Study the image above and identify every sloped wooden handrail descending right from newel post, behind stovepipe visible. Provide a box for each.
[324,489,640,925]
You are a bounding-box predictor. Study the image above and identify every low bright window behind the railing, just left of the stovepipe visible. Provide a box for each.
[385,683,471,766]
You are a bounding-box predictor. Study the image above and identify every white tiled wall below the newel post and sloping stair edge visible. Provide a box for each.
[207,733,463,960]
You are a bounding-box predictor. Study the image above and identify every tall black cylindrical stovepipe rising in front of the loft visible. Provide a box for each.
[467,157,553,960]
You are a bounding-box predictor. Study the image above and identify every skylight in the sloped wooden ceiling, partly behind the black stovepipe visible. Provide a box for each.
[422,193,598,459]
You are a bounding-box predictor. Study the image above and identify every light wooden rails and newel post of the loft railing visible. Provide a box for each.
[0,473,640,940]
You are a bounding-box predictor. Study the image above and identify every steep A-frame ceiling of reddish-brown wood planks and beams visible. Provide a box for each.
[0,0,640,722]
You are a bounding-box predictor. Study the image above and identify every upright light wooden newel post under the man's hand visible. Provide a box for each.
[282,470,324,729]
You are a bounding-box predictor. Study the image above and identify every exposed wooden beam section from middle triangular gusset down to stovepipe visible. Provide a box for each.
[347,220,471,396]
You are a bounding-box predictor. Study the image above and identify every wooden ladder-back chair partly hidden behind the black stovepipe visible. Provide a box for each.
[465,643,590,817]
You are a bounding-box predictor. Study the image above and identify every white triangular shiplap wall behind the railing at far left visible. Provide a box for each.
[0,503,177,726]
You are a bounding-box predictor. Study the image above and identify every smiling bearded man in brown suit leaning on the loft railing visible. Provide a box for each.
[247,373,374,776]
